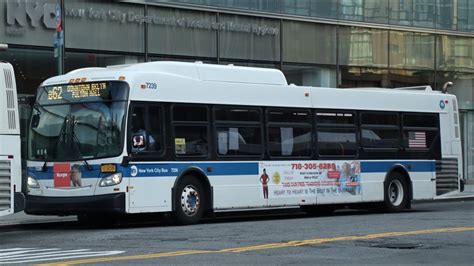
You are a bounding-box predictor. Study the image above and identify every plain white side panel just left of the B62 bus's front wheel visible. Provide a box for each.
[126,176,176,213]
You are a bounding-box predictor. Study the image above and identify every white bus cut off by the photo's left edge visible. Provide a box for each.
[0,62,24,216]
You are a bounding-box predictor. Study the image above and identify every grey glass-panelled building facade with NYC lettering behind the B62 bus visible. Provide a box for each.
[0,0,474,179]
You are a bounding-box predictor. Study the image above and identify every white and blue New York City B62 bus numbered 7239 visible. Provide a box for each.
[25,62,462,224]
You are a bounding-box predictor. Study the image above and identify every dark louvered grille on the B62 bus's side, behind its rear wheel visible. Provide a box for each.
[436,158,459,196]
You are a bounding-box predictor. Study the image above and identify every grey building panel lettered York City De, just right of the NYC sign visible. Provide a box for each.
[65,0,145,52]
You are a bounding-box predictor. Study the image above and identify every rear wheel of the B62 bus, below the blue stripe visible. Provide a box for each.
[383,172,410,212]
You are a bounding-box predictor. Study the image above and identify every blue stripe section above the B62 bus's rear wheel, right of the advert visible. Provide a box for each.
[360,161,436,173]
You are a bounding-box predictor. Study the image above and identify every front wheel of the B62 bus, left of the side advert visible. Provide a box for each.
[174,175,209,225]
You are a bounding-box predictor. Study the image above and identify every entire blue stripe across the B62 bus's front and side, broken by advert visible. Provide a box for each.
[28,161,436,180]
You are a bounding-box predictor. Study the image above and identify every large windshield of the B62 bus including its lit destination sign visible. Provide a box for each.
[28,81,128,161]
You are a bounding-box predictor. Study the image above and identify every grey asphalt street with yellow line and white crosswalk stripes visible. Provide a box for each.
[0,199,474,266]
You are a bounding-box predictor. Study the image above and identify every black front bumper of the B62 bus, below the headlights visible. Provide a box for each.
[25,193,125,215]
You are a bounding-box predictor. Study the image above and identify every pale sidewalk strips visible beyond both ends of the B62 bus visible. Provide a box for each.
[0,184,474,228]
